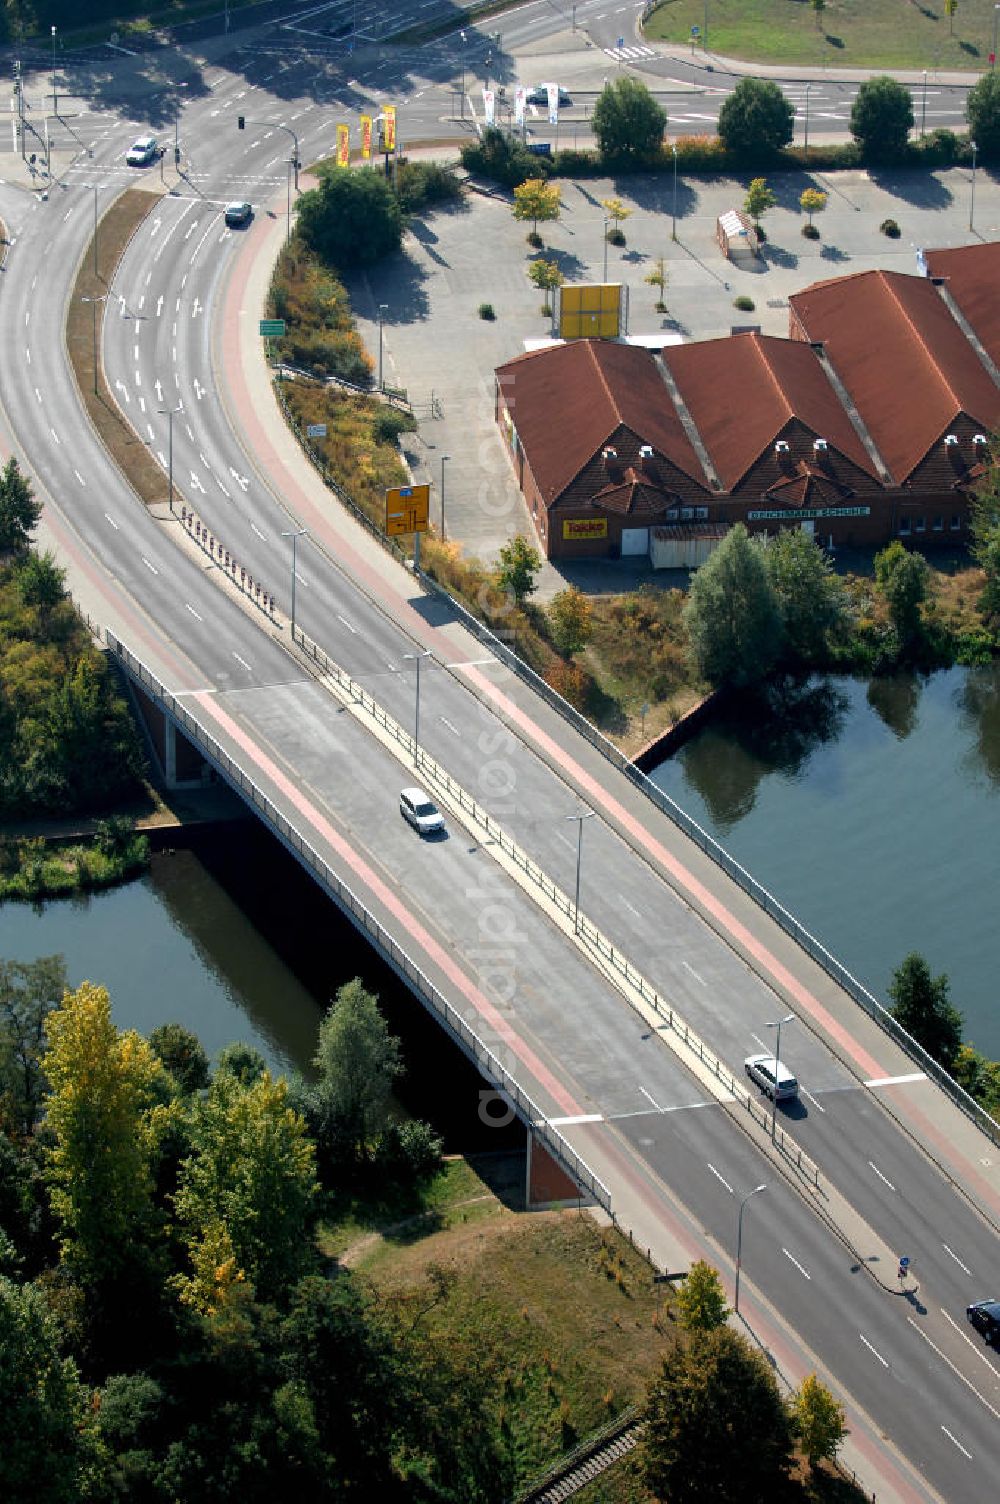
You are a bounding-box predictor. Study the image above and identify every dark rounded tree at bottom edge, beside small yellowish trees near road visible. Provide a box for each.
[639,1327,792,1504]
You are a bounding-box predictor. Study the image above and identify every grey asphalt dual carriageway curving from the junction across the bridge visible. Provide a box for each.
[0,8,1000,1504]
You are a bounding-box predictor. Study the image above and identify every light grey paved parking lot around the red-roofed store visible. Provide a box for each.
[350,154,1000,597]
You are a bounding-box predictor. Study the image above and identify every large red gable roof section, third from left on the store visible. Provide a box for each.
[788,271,1000,484]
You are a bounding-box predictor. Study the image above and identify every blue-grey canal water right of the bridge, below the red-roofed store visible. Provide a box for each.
[651,666,1000,1059]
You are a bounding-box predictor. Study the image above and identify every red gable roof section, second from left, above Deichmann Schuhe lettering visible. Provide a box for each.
[663,334,874,490]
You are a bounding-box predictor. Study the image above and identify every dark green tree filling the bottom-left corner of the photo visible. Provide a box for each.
[0,1275,95,1504]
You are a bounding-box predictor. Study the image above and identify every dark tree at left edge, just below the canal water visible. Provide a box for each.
[0,955,66,1137]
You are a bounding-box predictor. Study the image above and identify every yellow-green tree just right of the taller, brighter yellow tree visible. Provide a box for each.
[174,1071,317,1314]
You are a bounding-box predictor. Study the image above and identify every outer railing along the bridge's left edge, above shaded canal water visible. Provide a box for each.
[105,630,611,1211]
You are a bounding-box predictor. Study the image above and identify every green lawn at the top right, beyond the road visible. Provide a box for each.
[644,0,994,72]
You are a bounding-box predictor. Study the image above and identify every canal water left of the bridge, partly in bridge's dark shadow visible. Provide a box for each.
[0,820,502,1152]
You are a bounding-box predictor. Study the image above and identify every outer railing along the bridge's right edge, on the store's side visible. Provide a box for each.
[420,570,1000,1143]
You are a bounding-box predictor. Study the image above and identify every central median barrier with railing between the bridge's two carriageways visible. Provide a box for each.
[287,629,820,1187]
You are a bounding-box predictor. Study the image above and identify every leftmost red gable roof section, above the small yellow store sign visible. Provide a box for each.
[496,340,707,505]
